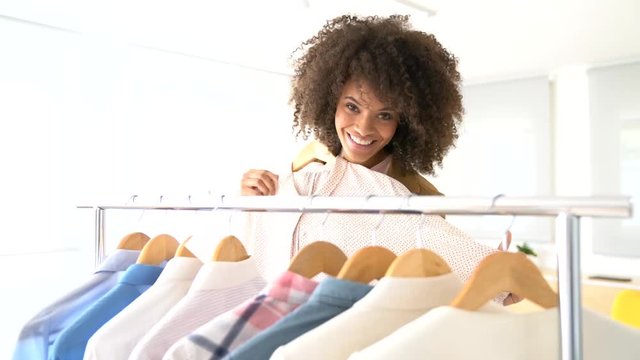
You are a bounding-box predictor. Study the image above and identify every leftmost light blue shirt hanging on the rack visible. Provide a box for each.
[13,250,140,360]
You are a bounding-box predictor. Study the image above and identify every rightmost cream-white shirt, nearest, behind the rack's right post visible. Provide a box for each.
[349,306,640,360]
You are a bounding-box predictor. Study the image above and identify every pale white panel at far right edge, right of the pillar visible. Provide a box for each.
[588,63,640,257]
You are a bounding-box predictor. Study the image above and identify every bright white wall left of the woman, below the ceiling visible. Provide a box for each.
[0,17,297,359]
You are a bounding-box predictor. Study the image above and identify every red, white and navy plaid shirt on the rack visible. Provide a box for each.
[163,271,318,360]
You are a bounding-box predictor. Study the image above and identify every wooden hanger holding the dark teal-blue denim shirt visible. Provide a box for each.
[338,246,396,284]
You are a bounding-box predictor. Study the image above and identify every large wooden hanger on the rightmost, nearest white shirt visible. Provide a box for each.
[451,251,558,310]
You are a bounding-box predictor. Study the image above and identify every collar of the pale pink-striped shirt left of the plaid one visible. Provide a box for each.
[189,257,260,291]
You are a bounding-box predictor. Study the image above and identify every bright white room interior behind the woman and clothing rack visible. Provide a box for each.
[0,0,640,359]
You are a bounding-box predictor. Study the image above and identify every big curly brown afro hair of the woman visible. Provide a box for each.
[290,15,464,174]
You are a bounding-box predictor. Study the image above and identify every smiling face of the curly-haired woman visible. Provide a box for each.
[335,80,399,168]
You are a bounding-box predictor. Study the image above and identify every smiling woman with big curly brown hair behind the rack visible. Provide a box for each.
[241,16,463,195]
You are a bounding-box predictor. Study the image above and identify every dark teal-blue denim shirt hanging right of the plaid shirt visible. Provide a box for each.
[224,278,372,360]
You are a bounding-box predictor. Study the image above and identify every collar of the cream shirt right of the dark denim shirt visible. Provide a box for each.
[354,273,462,310]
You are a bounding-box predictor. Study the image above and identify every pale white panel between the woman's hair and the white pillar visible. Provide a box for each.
[432,76,553,246]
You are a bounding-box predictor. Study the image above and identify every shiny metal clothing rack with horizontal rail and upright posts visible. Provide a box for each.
[79,195,632,360]
